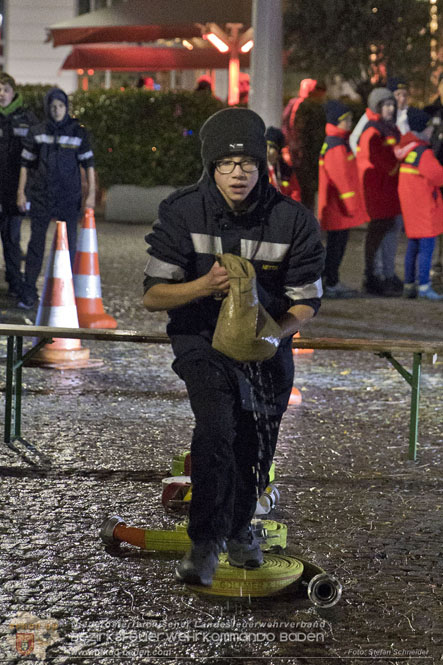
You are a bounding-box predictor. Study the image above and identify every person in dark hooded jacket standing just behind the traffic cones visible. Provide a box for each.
[17,88,95,309]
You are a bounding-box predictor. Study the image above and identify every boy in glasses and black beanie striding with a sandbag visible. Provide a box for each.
[143,108,324,586]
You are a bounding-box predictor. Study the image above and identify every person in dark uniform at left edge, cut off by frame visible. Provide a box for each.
[0,72,38,298]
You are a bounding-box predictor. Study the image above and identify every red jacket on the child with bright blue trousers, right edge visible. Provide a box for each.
[396,132,443,238]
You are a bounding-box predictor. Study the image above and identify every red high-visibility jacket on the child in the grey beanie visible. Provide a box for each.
[357,108,400,219]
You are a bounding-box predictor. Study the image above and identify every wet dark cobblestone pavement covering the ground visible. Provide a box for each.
[0,221,443,665]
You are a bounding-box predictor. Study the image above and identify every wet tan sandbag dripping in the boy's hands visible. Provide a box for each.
[212,254,281,363]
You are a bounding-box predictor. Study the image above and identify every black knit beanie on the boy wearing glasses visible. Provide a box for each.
[200,107,266,175]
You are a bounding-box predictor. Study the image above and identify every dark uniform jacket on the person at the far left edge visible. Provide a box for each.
[0,95,38,216]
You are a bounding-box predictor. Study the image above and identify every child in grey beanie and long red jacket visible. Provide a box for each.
[357,88,403,296]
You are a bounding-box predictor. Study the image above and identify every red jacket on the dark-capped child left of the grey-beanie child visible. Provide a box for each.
[318,123,369,231]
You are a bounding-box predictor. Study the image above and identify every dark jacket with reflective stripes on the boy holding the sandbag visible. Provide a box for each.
[144,175,324,414]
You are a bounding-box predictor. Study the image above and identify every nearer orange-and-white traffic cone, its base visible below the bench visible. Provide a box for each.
[31,222,89,369]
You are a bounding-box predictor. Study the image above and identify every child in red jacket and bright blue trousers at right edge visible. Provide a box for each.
[396,107,443,300]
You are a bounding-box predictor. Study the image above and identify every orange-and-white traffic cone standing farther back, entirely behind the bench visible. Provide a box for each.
[74,208,117,328]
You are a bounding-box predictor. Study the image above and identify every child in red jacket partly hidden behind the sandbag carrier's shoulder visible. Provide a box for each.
[265,127,301,202]
